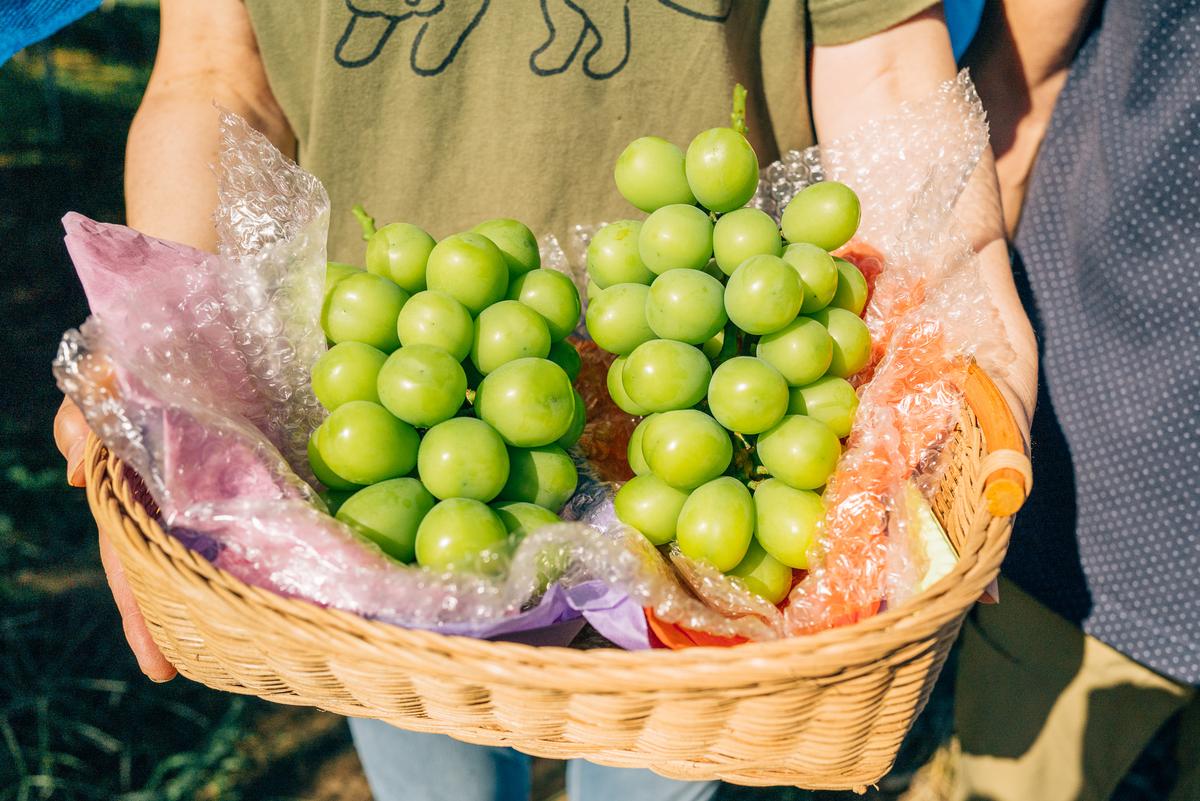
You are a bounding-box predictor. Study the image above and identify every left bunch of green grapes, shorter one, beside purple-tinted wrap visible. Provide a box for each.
[308,207,580,570]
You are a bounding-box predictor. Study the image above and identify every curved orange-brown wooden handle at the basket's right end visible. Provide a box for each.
[964,362,1033,517]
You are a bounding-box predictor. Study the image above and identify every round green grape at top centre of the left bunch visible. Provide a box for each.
[425,231,509,315]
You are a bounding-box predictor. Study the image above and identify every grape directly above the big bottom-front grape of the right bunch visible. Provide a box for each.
[642,409,733,489]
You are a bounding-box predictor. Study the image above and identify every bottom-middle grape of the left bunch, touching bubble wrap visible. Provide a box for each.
[415,498,509,570]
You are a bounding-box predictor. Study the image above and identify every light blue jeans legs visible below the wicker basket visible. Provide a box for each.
[350,718,720,801]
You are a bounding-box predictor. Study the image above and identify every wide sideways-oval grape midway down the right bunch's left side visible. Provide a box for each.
[620,339,710,411]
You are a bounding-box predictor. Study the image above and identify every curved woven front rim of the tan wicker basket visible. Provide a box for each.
[86,372,1022,682]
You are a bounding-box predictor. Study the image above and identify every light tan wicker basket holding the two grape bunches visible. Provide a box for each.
[86,362,1030,789]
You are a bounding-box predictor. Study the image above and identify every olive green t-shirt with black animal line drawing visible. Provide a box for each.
[245,0,934,263]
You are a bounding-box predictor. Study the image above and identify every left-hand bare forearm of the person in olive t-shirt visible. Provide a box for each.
[125,0,295,251]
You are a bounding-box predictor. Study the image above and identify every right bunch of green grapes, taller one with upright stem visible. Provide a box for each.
[597,86,871,603]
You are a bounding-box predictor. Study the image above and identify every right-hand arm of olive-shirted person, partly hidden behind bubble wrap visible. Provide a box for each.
[812,8,1037,435]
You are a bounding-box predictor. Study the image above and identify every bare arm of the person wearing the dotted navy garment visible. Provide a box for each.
[965,0,1094,236]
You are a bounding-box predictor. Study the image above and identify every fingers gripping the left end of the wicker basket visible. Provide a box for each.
[54,398,176,682]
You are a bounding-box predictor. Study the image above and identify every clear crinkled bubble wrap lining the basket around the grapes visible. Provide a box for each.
[55,76,1006,648]
